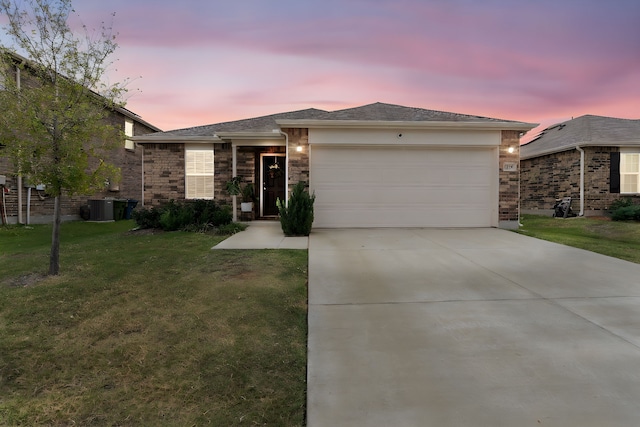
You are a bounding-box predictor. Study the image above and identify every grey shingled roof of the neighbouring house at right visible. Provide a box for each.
[520,115,640,159]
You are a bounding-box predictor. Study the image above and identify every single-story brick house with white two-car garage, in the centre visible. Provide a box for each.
[134,103,536,228]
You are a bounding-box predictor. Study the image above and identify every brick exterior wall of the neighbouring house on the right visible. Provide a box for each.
[520,147,640,216]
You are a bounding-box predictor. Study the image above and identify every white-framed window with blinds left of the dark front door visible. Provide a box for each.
[184,144,215,200]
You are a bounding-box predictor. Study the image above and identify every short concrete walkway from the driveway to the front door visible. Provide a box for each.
[211,221,309,249]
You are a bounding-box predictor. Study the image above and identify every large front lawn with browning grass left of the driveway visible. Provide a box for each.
[0,221,307,426]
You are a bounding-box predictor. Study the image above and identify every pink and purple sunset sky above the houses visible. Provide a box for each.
[1,0,640,139]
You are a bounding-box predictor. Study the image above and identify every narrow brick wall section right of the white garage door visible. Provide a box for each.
[498,130,520,223]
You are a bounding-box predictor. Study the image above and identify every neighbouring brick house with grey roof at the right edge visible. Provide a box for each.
[520,115,640,216]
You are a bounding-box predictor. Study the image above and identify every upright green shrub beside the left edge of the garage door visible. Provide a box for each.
[277,181,316,236]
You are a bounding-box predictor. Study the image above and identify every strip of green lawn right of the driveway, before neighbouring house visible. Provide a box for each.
[518,215,640,263]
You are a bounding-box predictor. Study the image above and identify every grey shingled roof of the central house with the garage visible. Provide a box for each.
[134,102,536,142]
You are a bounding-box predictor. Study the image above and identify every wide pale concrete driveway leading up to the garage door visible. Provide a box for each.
[307,229,640,427]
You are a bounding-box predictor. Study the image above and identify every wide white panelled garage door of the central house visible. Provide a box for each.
[310,146,498,228]
